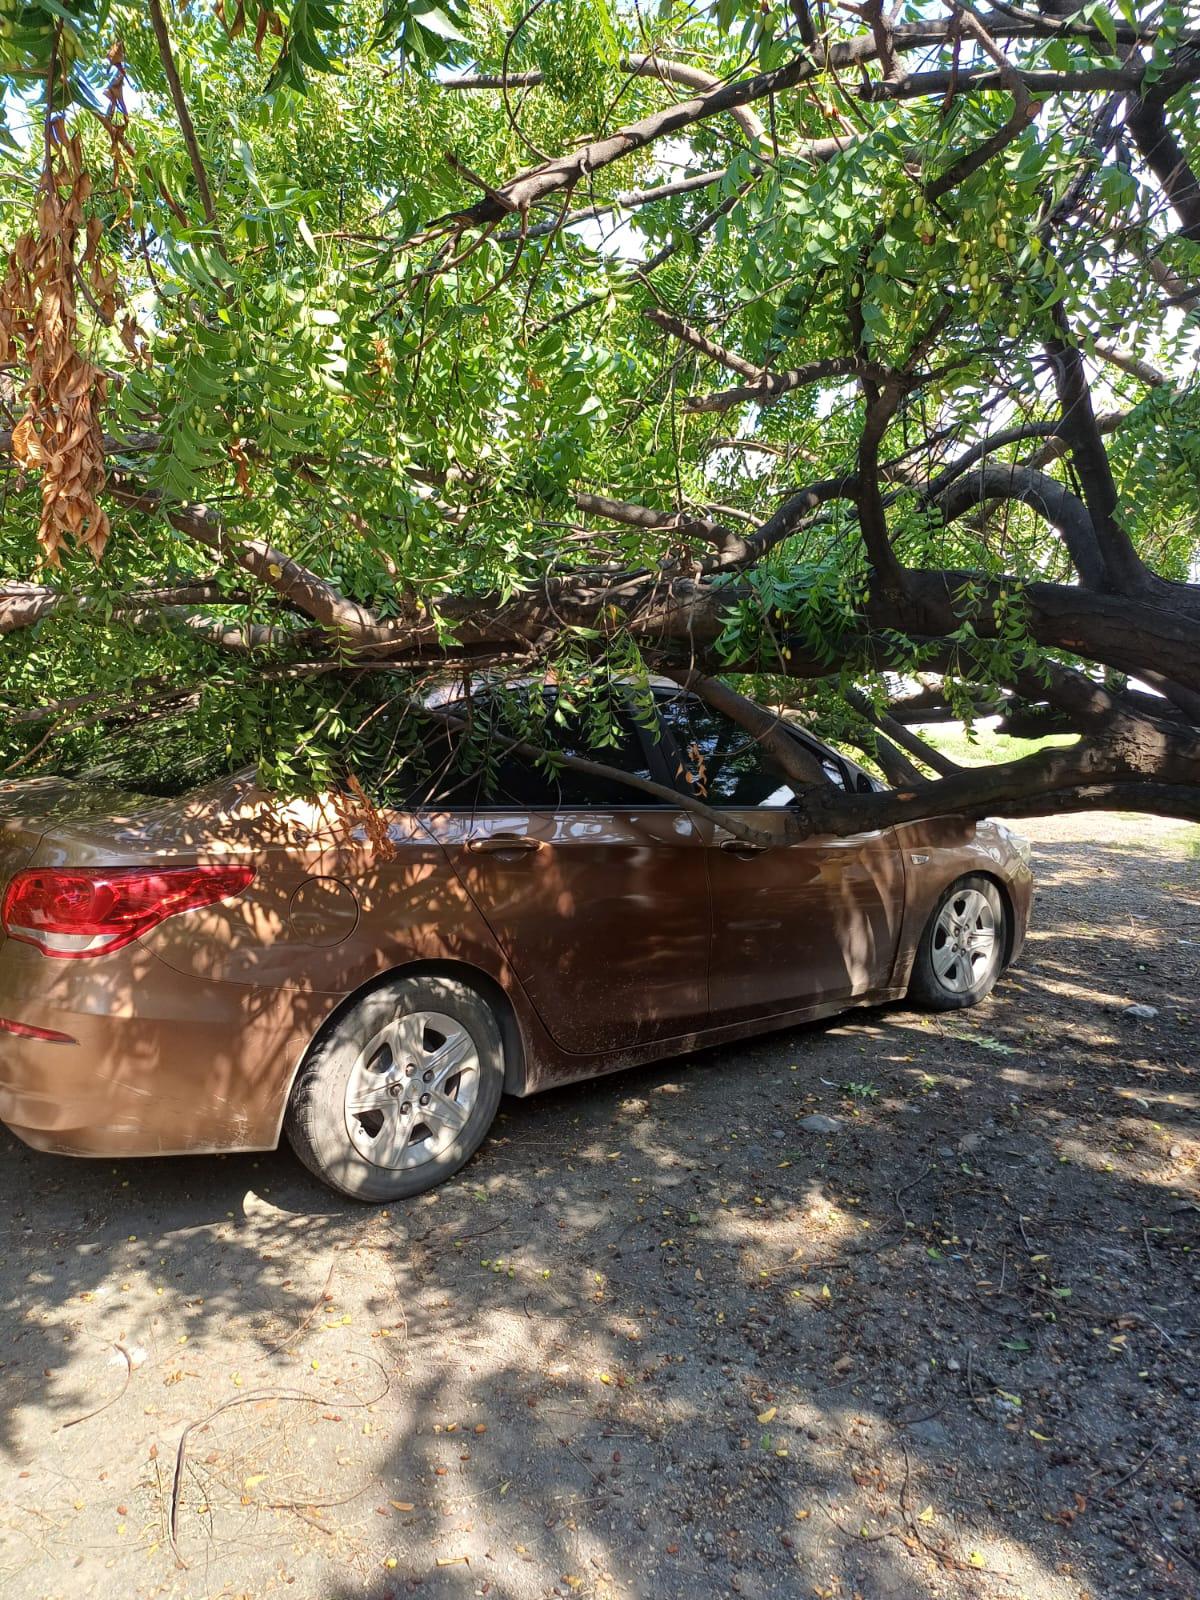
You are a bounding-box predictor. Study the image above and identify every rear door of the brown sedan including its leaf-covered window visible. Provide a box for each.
[422,691,709,1054]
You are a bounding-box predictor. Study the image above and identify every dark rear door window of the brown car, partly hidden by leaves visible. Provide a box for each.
[376,690,656,811]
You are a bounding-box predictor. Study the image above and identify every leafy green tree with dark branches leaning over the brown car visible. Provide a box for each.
[0,0,1200,829]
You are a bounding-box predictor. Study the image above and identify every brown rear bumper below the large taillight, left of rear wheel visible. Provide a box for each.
[0,939,336,1155]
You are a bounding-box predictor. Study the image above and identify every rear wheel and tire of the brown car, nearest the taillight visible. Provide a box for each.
[283,976,504,1202]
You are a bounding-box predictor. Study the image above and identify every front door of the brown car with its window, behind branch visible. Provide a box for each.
[659,694,904,1022]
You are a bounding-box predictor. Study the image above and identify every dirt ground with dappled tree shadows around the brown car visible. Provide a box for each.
[0,816,1200,1600]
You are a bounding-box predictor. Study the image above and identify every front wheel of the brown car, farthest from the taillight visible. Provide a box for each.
[909,877,1008,1011]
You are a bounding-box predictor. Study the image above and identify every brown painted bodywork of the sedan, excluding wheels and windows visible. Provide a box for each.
[0,688,1030,1203]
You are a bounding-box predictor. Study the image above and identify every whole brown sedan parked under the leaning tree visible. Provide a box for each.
[0,690,1030,1200]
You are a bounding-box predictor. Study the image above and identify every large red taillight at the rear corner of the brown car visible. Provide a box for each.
[0,867,254,960]
